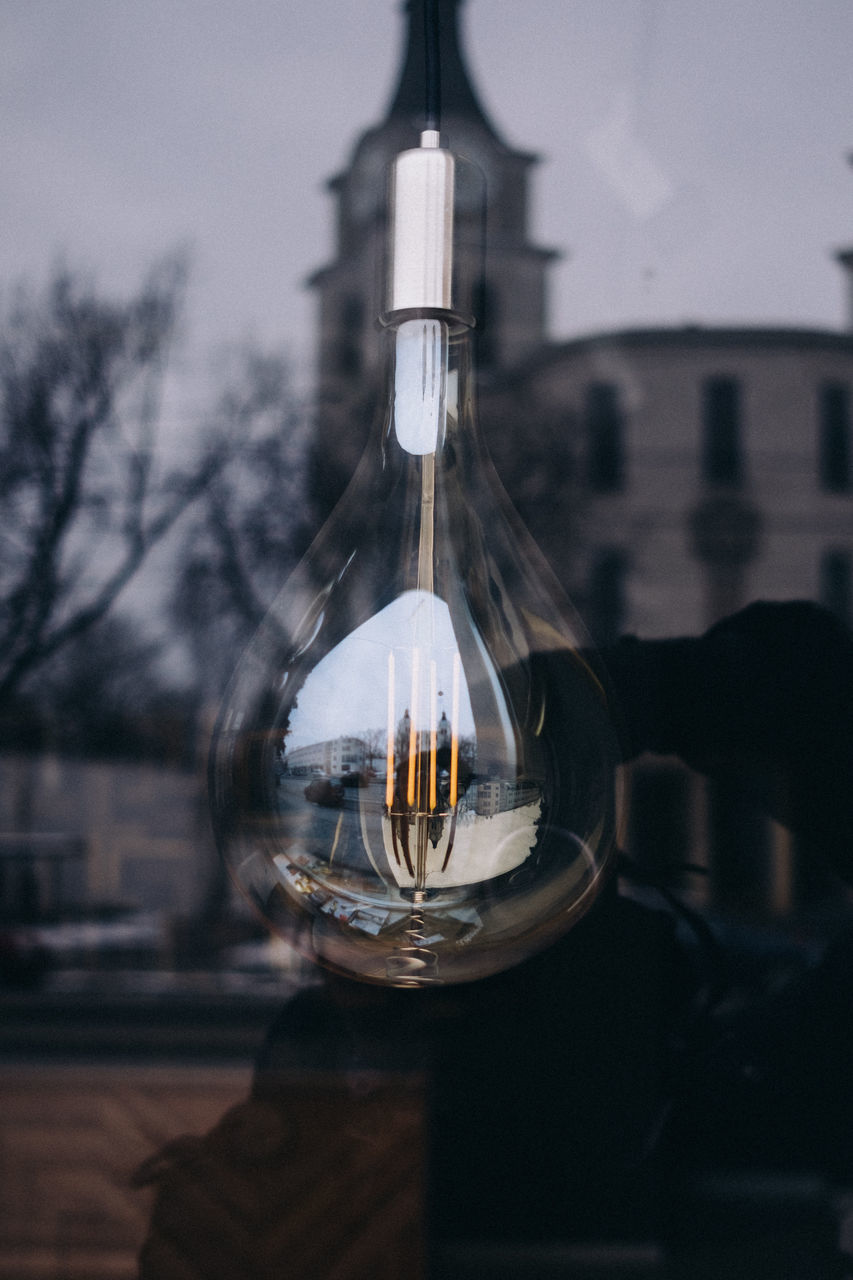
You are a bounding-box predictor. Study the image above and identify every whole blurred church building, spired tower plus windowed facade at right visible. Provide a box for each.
[311,0,853,910]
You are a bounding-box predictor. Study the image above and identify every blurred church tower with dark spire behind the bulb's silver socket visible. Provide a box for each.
[310,0,555,508]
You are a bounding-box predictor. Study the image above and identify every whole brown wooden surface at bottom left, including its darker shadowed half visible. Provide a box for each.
[0,1066,423,1280]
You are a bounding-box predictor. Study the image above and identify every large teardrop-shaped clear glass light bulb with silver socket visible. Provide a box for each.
[210,134,619,986]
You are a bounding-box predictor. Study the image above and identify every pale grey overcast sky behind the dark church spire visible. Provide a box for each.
[0,0,853,419]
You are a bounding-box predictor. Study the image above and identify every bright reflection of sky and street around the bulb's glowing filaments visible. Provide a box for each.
[279,591,532,896]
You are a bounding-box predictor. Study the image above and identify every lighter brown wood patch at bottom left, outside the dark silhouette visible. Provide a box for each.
[0,1065,250,1280]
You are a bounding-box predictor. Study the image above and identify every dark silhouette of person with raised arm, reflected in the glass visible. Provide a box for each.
[133,603,853,1280]
